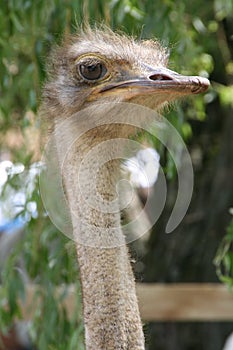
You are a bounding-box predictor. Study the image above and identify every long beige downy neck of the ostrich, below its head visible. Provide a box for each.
[58,130,144,350]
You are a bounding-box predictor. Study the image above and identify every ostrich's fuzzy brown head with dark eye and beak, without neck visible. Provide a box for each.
[44,28,209,116]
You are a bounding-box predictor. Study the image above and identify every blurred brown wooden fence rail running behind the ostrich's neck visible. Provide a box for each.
[13,283,233,321]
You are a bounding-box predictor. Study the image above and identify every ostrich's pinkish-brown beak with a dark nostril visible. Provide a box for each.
[98,67,210,100]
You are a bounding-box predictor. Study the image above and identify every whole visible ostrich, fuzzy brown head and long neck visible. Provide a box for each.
[42,28,209,350]
